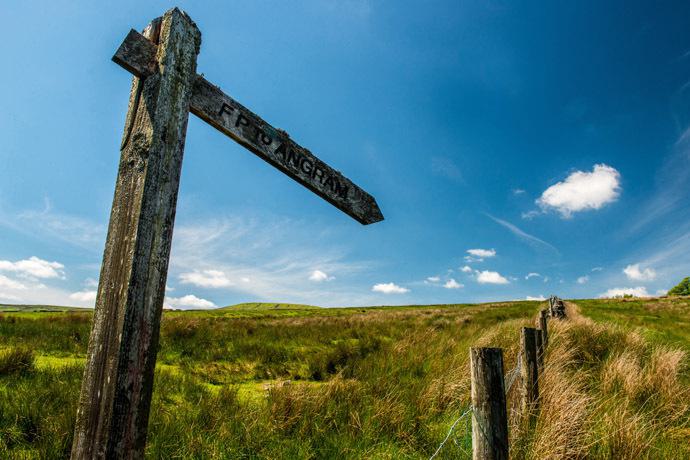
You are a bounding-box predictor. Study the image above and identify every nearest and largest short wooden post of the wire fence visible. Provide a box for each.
[470,348,508,460]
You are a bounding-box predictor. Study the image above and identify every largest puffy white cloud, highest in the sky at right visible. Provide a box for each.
[536,164,621,218]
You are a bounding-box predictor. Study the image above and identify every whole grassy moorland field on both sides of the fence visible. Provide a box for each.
[0,299,690,459]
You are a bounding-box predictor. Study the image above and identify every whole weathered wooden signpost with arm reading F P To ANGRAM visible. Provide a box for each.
[72,8,383,459]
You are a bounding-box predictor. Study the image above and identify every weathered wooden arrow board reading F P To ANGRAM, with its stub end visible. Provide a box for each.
[113,27,383,225]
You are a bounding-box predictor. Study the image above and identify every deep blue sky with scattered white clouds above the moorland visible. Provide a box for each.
[0,0,690,308]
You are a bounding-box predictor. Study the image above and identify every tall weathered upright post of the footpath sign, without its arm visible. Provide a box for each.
[72,9,201,459]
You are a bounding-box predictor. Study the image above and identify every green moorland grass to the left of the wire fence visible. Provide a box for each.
[0,302,539,458]
